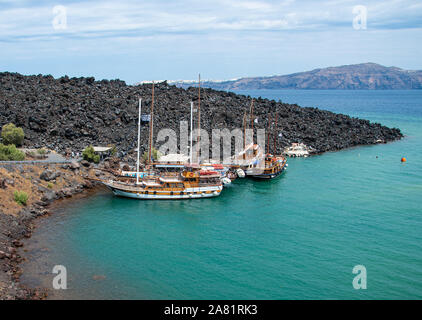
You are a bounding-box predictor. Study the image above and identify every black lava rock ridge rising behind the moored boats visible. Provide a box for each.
[0,73,402,156]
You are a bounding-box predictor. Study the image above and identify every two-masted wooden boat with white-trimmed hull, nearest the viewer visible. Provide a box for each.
[103,84,223,199]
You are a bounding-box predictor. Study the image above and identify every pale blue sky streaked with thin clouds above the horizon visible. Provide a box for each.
[0,0,422,83]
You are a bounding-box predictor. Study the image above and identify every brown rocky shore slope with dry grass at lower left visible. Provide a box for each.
[0,163,98,300]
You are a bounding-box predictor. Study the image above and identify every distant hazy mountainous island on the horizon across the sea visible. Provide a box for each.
[169,63,422,91]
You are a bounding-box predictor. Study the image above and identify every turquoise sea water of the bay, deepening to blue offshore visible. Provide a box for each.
[23,90,422,299]
